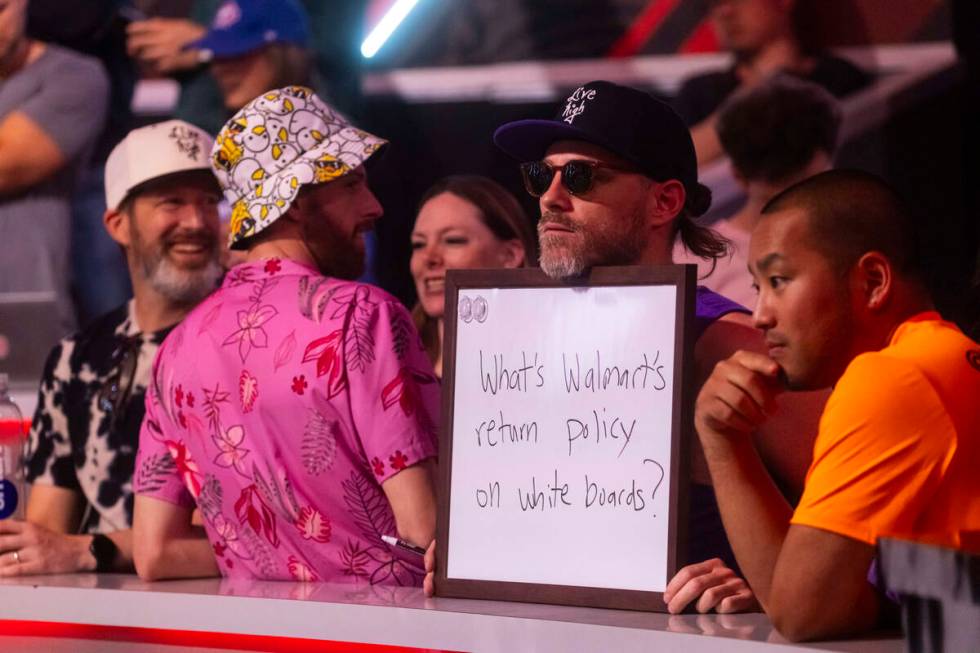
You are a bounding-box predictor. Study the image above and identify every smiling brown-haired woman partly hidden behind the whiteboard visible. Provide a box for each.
[411,175,537,378]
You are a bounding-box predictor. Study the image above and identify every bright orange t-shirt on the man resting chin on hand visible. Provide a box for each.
[792,313,980,552]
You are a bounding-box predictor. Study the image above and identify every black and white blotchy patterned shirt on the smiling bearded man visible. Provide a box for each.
[27,301,170,533]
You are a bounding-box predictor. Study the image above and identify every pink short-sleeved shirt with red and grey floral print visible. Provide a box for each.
[134,259,439,585]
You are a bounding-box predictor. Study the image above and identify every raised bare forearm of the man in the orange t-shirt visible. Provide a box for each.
[701,435,792,611]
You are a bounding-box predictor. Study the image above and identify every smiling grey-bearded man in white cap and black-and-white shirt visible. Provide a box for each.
[0,120,220,576]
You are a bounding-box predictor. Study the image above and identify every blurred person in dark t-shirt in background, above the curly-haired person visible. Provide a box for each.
[674,0,871,165]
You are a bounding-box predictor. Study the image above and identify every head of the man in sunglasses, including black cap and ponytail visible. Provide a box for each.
[493,81,720,278]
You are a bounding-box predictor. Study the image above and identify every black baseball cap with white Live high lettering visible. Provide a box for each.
[493,81,698,194]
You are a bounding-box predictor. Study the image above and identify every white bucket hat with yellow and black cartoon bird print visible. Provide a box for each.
[211,86,387,249]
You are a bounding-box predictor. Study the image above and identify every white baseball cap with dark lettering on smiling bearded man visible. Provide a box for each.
[105,120,217,209]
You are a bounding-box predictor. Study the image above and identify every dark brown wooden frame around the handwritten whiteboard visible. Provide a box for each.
[435,265,697,612]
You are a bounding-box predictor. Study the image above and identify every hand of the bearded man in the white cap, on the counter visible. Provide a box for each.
[0,519,95,578]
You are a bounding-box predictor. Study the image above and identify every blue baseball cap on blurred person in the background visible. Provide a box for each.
[188,0,310,59]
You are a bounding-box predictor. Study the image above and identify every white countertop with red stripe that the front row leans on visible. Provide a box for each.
[0,574,904,653]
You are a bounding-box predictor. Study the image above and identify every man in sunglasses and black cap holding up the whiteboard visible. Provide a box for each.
[482,81,823,612]
